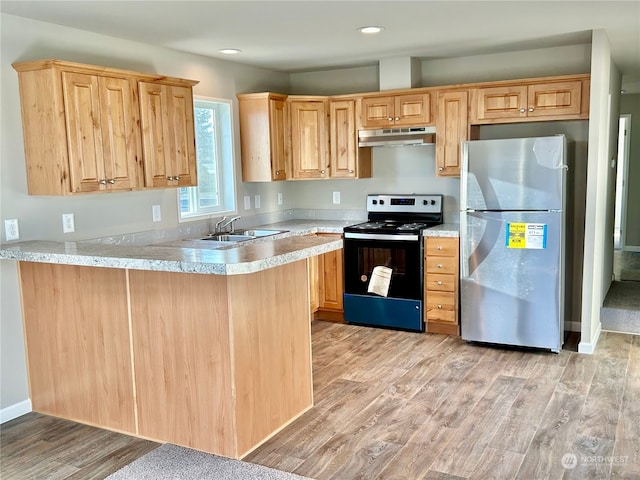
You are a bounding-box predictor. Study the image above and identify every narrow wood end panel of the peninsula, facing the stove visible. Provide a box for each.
[228,260,313,457]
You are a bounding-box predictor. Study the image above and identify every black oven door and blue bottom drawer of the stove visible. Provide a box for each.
[344,235,424,331]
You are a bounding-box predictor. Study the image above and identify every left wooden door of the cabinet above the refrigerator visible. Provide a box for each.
[471,85,527,122]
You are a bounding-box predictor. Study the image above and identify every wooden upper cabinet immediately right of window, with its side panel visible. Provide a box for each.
[238,92,289,182]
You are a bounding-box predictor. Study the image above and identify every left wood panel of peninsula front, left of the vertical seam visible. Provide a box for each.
[20,262,135,433]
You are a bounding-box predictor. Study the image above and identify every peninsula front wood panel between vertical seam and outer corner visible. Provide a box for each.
[129,270,235,457]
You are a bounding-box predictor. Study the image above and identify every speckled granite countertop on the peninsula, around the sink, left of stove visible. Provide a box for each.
[0,220,354,275]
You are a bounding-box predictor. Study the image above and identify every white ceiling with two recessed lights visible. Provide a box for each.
[0,0,640,78]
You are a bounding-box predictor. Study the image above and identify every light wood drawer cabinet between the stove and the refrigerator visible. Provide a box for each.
[424,237,460,335]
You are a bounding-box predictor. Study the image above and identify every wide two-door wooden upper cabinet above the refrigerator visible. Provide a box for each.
[471,77,589,124]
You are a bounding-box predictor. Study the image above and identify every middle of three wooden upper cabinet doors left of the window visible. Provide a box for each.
[98,77,139,190]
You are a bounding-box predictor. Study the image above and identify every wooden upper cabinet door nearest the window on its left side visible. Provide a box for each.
[139,82,197,187]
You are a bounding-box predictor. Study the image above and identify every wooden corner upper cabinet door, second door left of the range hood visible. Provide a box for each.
[289,100,329,179]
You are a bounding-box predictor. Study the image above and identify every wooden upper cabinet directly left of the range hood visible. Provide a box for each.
[329,99,371,178]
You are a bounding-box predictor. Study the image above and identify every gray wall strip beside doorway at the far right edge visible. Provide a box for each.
[620,93,640,249]
